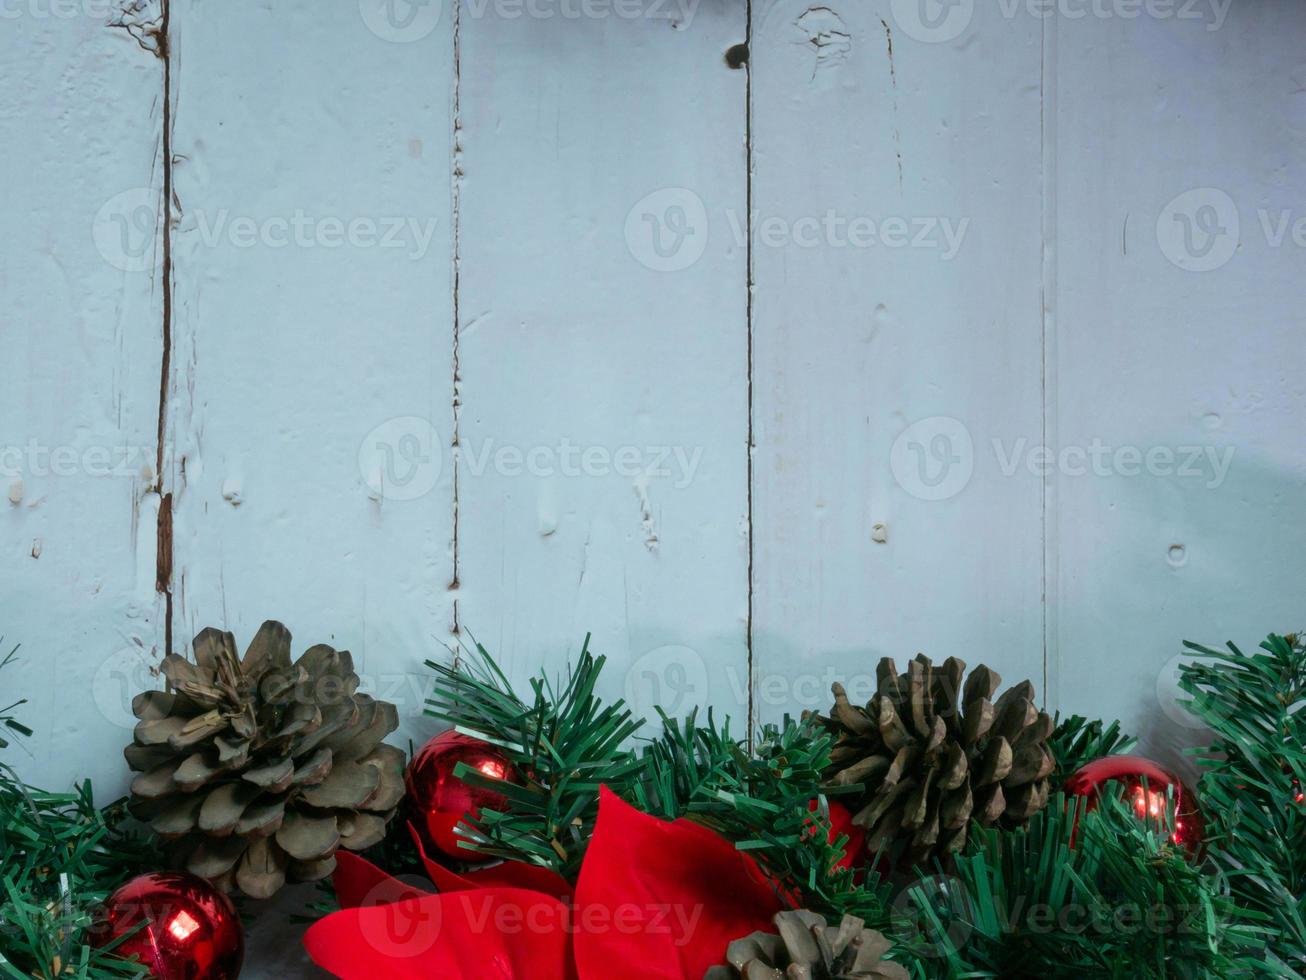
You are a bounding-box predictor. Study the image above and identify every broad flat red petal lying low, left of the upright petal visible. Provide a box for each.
[304,889,575,980]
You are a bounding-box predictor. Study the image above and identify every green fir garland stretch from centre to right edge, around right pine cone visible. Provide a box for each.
[428,636,1306,980]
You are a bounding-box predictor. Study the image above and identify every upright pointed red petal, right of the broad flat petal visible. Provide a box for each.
[576,787,781,980]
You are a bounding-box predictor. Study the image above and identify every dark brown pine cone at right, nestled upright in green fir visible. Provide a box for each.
[824,656,1055,861]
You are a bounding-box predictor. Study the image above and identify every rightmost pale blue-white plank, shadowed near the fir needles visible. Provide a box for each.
[1053,4,1306,763]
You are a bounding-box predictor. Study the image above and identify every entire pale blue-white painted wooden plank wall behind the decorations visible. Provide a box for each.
[0,0,1306,961]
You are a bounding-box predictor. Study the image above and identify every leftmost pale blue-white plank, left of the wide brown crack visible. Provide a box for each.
[0,3,163,798]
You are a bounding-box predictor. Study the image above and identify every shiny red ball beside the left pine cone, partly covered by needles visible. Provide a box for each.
[406,730,520,861]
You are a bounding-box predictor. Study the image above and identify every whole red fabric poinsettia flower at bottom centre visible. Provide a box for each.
[304,788,781,980]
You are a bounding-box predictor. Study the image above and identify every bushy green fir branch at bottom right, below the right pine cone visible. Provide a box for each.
[899,793,1284,980]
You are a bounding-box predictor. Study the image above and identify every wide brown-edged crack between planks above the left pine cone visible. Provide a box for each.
[154,0,172,653]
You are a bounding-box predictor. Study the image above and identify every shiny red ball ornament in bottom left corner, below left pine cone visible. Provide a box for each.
[89,872,244,980]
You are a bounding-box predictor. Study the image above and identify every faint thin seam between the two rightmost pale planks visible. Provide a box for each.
[1040,17,1059,707]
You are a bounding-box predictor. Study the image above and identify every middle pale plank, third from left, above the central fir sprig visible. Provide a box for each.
[458,0,747,720]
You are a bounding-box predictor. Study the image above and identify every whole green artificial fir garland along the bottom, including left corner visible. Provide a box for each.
[0,624,1306,980]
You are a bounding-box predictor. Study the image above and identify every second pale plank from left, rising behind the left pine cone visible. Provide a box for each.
[167,0,453,743]
